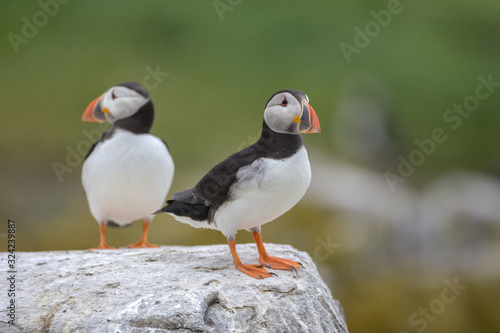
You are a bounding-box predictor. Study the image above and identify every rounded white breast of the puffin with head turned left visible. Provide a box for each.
[82,130,174,225]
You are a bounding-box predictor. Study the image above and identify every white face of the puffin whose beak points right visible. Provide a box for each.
[264,92,309,134]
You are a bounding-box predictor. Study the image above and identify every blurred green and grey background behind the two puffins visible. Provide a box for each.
[0,0,500,333]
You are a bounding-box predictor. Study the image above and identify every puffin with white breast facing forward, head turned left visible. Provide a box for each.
[82,82,174,249]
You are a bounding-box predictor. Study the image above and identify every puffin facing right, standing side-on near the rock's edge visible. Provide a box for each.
[155,89,321,279]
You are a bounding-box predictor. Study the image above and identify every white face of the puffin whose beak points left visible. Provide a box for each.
[101,86,149,123]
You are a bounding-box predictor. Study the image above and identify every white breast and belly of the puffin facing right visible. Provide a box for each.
[215,147,311,237]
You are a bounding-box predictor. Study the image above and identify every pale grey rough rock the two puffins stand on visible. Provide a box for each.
[0,244,347,333]
